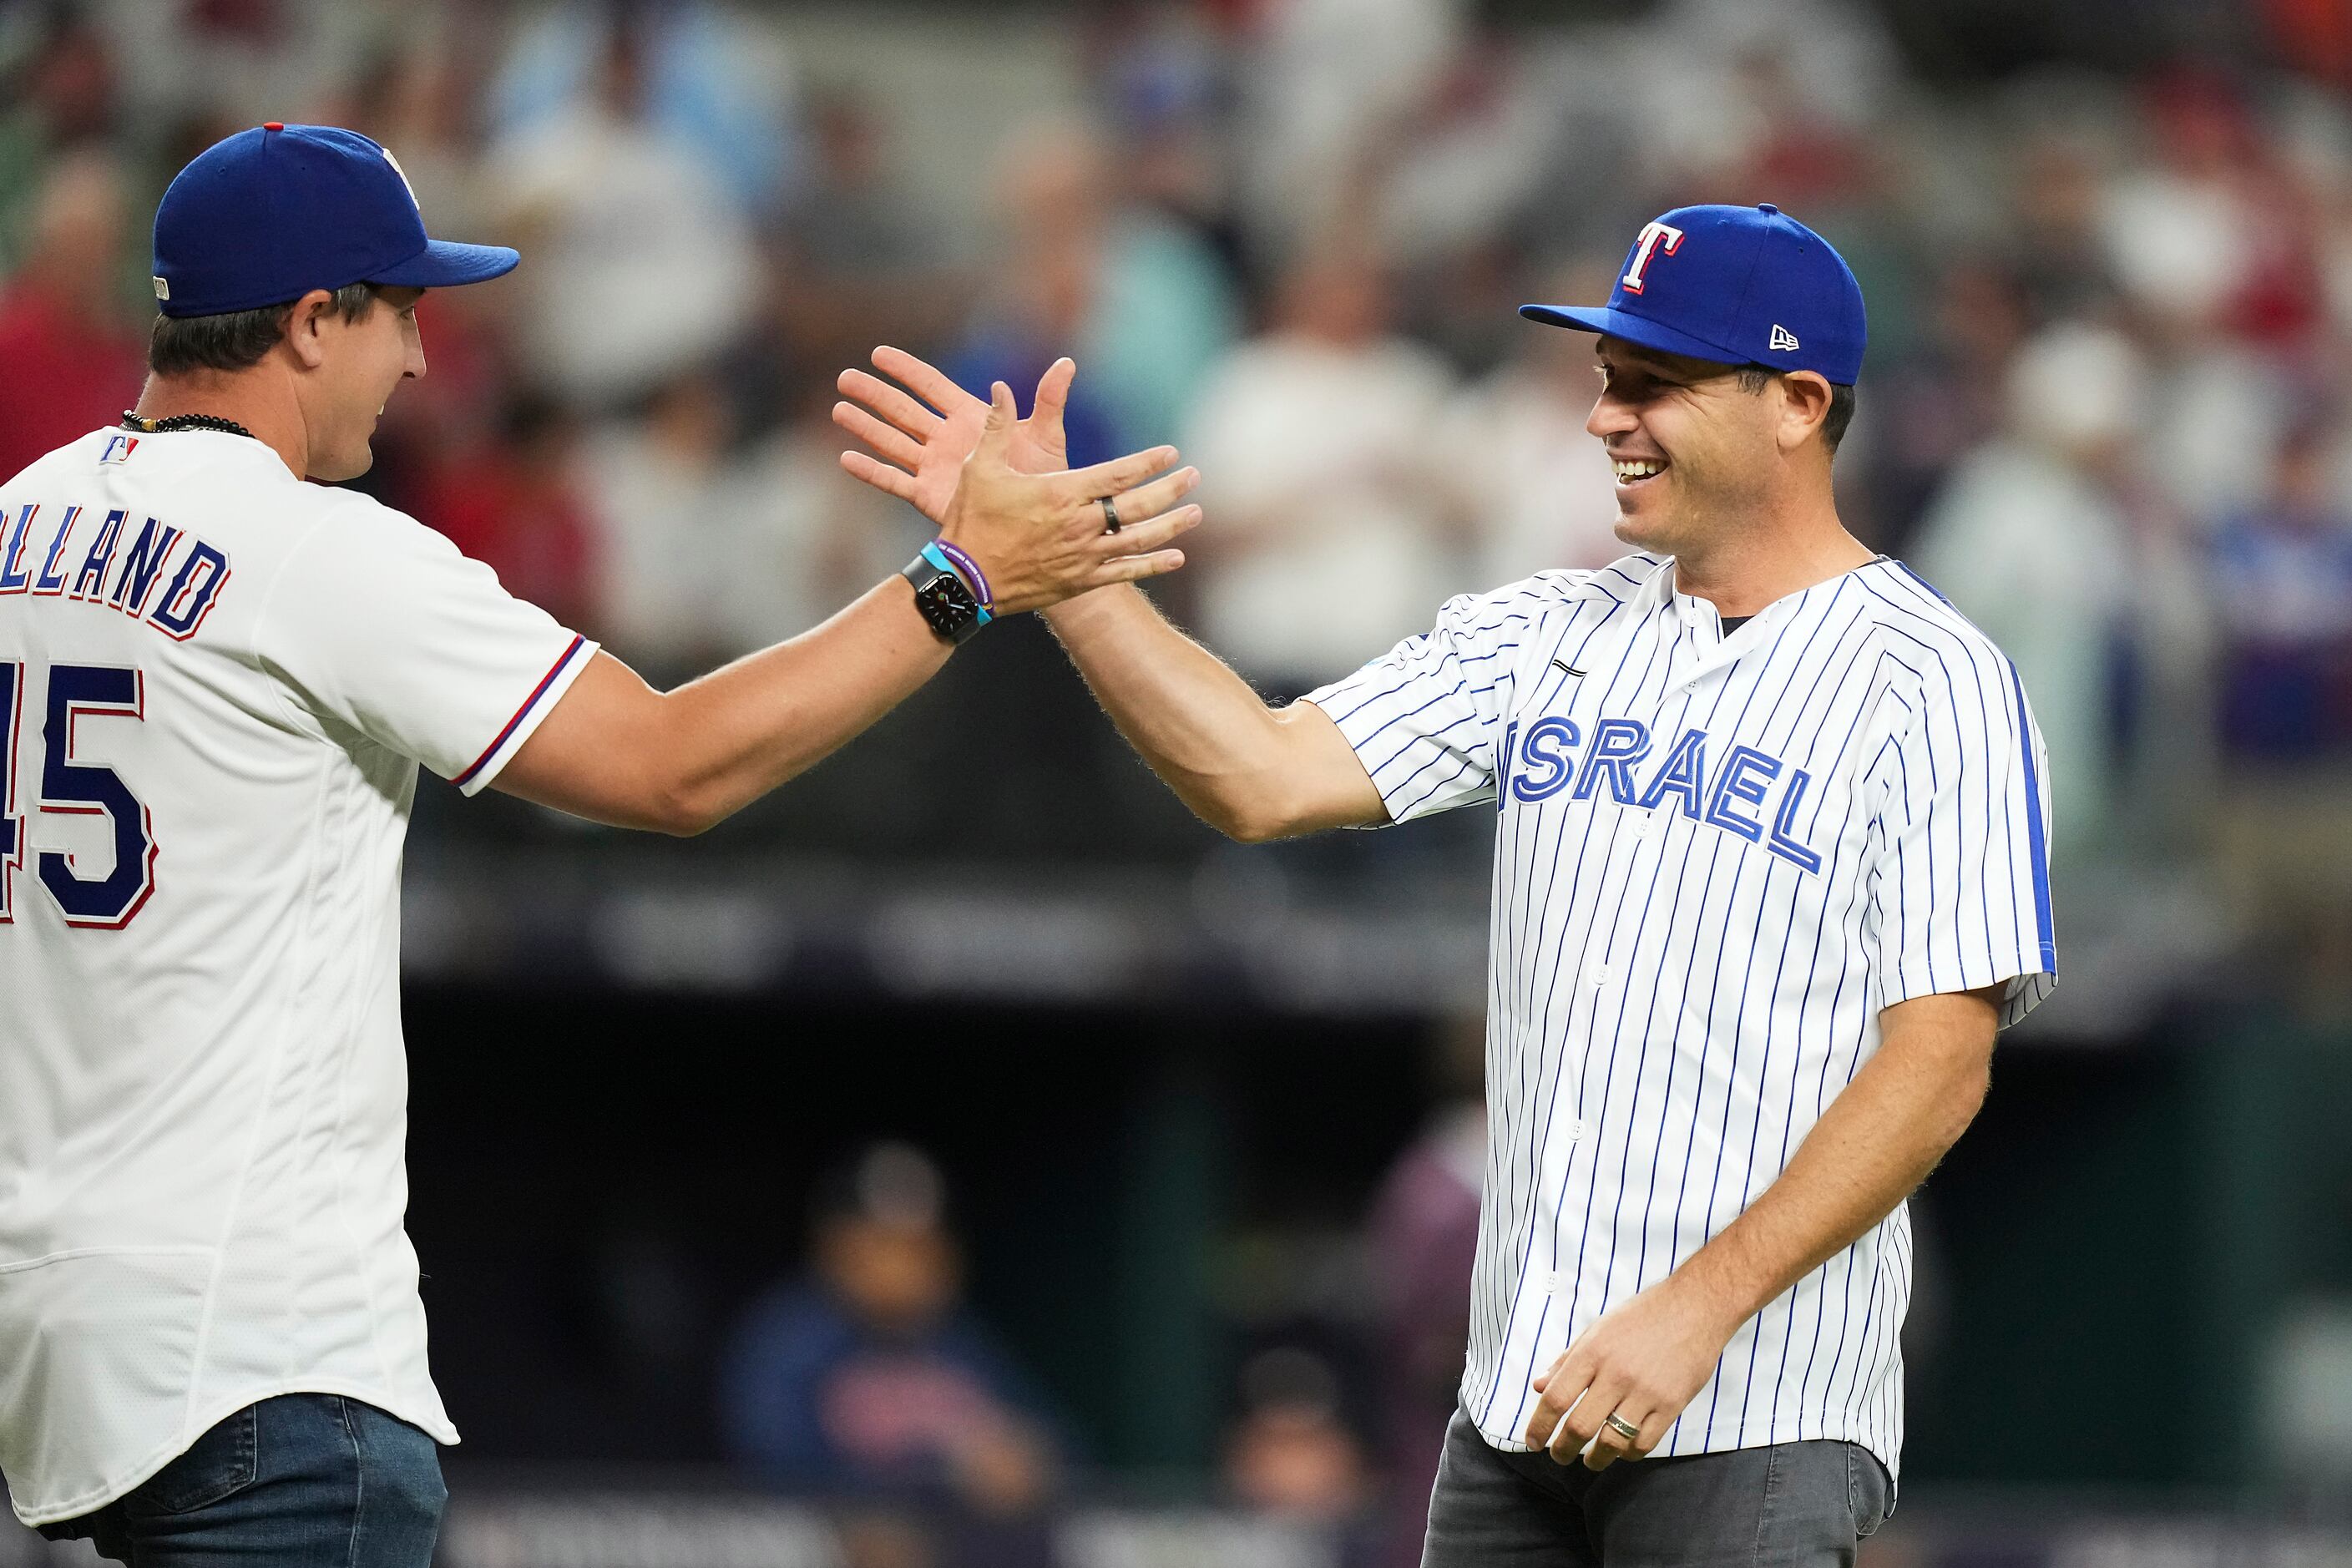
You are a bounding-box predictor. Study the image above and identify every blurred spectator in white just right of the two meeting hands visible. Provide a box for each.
[1183,245,1465,694]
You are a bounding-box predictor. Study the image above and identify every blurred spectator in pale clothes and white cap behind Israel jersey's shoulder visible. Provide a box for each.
[1917,326,2147,856]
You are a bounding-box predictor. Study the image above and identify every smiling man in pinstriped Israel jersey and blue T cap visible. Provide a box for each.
[837,207,2056,1568]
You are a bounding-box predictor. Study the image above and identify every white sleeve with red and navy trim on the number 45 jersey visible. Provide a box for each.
[254,501,595,795]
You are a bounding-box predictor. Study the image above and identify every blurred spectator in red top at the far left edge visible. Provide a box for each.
[0,150,146,475]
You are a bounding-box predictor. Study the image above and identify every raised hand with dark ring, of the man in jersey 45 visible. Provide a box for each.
[936,382,1200,616]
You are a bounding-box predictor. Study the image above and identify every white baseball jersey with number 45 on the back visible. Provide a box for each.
[0,430,590,1524]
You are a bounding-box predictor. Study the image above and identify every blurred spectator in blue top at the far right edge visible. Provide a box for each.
[2211,423,2352,764]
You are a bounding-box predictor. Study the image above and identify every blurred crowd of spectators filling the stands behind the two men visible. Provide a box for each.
[13,0,2352,921]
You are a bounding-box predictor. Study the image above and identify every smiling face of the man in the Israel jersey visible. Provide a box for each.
[1586,336,1783,554]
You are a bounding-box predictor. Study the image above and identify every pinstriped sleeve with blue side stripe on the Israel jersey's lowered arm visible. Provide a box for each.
[1872,654,2058,1029]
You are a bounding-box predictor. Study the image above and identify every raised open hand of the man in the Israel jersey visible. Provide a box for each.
[832,348,1077,522]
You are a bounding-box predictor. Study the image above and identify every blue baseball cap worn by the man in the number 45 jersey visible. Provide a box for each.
[155,120,522,315]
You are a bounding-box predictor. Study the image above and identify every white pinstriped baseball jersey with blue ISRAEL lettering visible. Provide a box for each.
[1308,554,2056,1472]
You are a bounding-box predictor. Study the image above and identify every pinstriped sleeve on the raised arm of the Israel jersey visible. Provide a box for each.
[1301,594,1529,822]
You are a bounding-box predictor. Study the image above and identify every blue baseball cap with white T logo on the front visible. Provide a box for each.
[1520,202,1870,386]
